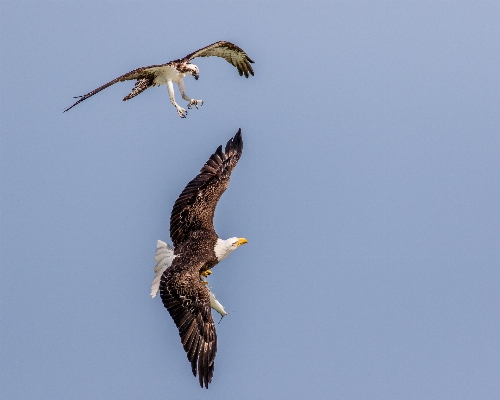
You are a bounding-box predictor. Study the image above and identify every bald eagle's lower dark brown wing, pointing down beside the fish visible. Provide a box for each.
[160,256,217,389]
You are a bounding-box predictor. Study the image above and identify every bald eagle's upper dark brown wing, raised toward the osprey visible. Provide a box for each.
[170,129,243,247]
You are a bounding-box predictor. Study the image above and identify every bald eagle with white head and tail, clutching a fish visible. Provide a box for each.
[151,129,247,389]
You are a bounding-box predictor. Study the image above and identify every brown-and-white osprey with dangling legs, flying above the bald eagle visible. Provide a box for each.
[63,41,254,118]
